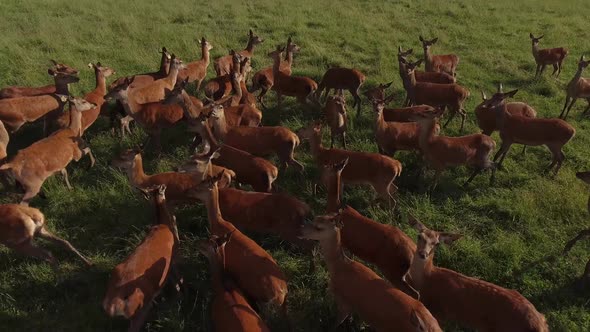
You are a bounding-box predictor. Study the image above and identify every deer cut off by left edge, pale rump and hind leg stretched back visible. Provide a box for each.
[0,204,92,271]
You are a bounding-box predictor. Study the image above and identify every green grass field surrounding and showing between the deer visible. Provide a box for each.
[0,0,590,331]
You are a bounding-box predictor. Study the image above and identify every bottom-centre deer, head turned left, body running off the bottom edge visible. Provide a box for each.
[301,213,442,332]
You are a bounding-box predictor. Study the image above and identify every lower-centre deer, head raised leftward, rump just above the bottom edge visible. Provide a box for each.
[189,174,288,317]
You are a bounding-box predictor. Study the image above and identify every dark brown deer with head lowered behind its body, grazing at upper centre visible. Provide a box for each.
[315,67,366,118]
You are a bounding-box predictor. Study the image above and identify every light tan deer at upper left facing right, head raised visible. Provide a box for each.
[129,54,185,104]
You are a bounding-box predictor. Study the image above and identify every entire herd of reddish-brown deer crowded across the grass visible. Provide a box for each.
[0,30,590,332]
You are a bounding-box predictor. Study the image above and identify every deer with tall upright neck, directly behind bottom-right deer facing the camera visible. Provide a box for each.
[323,159,418,297]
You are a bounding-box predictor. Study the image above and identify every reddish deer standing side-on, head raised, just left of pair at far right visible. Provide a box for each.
[414,110,496,190]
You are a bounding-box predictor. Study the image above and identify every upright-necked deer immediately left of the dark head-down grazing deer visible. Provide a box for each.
[268,46,318,109]
